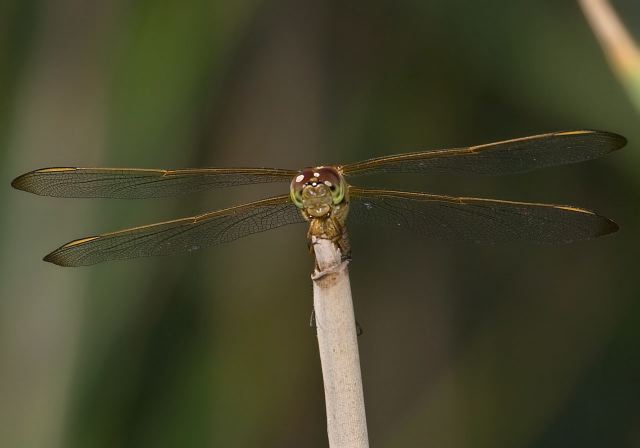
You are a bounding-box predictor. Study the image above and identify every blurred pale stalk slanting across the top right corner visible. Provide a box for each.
[578,0,640,110]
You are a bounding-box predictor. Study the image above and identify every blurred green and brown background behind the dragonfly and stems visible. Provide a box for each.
[0,0,640,448]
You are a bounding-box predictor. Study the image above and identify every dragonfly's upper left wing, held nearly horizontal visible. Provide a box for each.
[11,168,296,199]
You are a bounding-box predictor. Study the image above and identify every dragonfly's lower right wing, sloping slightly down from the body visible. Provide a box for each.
[349,187,618,243]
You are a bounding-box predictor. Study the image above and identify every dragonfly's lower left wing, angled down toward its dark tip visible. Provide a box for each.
[44,195,304,266]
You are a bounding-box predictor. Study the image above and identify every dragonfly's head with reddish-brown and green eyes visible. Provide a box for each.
[290,166,347,218]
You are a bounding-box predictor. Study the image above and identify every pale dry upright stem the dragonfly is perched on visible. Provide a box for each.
[311,237,369,448]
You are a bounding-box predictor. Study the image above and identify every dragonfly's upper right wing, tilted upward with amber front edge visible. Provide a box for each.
[341,130,627,176]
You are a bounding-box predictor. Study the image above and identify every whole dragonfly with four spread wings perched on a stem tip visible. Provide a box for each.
[12,130,626,266]
